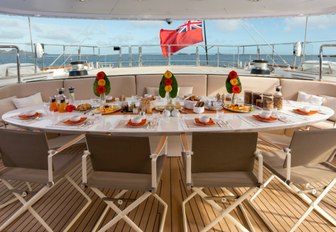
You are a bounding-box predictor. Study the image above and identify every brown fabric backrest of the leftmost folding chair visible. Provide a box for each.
[0,129,49,170]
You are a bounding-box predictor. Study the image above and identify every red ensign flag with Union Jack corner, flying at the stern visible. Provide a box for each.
[160,21,203,57]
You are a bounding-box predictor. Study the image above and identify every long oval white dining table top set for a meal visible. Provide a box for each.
[2,101,334,135]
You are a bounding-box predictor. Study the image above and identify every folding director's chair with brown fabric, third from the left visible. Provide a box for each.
[181,132,263,231]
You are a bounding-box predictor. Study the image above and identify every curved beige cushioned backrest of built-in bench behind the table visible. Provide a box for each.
[0,73,336,131]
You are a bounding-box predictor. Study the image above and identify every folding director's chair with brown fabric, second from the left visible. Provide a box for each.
[82,134,168,231]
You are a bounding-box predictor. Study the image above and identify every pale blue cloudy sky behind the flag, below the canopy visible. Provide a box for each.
[0,15,336,54]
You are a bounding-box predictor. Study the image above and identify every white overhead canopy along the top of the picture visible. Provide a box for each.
[0,0,336,20]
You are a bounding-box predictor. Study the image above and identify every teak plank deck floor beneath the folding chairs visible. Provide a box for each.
[0,140,336,232]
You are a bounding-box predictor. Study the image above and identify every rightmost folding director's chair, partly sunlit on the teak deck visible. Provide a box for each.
[251,129,336,231]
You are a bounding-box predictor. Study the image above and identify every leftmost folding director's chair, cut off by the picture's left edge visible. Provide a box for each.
[0,129,91,231]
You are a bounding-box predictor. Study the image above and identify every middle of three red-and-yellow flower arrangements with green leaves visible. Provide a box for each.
[159,70,178,98]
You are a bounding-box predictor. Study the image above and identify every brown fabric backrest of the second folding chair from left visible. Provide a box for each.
[86,134,151,174]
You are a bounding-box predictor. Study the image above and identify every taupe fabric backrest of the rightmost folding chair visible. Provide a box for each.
[284,129,336,168]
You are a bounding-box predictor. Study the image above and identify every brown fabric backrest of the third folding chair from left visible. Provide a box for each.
[191,132,258,173]
